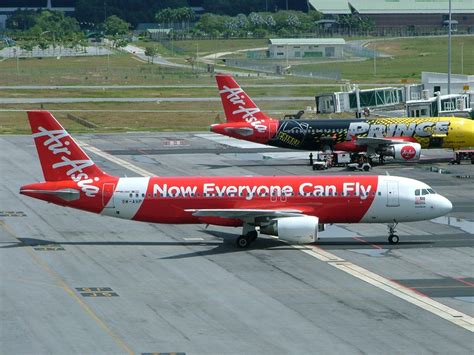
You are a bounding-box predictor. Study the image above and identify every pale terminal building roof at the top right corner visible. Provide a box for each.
[309,0,474,14]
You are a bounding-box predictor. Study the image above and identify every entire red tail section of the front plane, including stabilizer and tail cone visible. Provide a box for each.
[20,111,119,213]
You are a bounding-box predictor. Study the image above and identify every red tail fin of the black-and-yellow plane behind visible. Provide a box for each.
[216,74,270,123]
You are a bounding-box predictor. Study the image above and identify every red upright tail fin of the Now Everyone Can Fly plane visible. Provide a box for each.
[28,111,106,181]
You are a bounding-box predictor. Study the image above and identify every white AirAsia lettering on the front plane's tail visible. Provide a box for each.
[33,127,99,197]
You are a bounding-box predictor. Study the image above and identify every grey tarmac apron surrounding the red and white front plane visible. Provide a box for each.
[0,133,474,354]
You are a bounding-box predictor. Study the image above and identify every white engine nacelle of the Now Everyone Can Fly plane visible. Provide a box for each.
[260,216,324,244]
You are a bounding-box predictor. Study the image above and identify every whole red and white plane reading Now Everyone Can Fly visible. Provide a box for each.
[20,111,452,248]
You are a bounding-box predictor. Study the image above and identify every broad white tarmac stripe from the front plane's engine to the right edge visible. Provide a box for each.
[293,245,474,332]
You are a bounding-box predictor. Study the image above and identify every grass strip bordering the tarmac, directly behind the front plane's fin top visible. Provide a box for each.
[0,100,314,134]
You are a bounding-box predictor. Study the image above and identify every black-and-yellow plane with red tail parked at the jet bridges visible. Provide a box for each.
[211,74,474,161]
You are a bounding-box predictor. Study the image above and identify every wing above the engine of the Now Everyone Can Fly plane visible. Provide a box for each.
[186,209,304,220]
